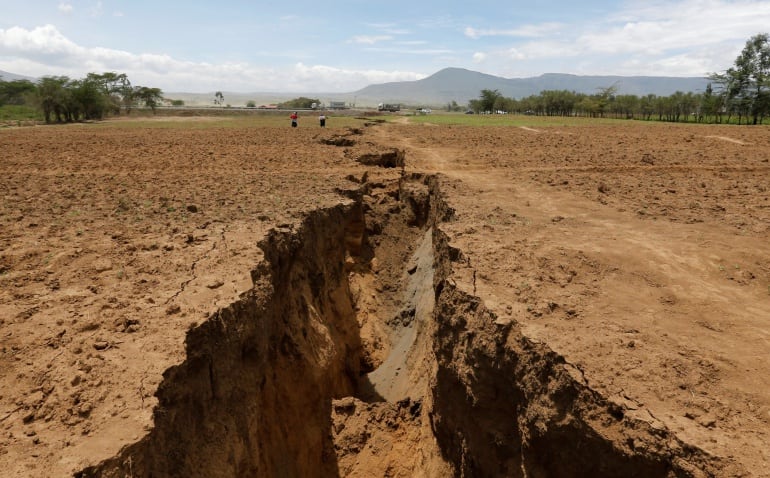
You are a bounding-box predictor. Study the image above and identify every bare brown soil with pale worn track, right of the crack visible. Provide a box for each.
[380,123,770,476]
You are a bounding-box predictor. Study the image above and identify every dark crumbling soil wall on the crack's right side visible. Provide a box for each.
[432,232,722,477]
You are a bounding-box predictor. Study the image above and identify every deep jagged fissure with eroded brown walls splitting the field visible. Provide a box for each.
[78,152,717,477]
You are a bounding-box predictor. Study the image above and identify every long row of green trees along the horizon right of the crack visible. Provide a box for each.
[462,33,770,124]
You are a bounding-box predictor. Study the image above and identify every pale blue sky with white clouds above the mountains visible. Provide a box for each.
[0,0,770,93]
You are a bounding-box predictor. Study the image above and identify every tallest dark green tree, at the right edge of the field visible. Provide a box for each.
[710,33,770,124]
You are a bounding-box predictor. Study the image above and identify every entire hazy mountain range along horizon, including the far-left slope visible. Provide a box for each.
[0,68,709,107]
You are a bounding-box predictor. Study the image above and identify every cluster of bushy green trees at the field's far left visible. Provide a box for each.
[0,72,163,123]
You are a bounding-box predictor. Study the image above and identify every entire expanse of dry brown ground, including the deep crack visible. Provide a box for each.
[0,116,770,477]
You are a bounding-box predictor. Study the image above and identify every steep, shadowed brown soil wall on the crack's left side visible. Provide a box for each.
[81,203,368,477]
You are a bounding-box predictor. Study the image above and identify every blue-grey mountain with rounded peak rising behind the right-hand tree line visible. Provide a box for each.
[352,68,709,105]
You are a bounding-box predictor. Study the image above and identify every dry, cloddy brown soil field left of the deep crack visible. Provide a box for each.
[0,125,372,476]
